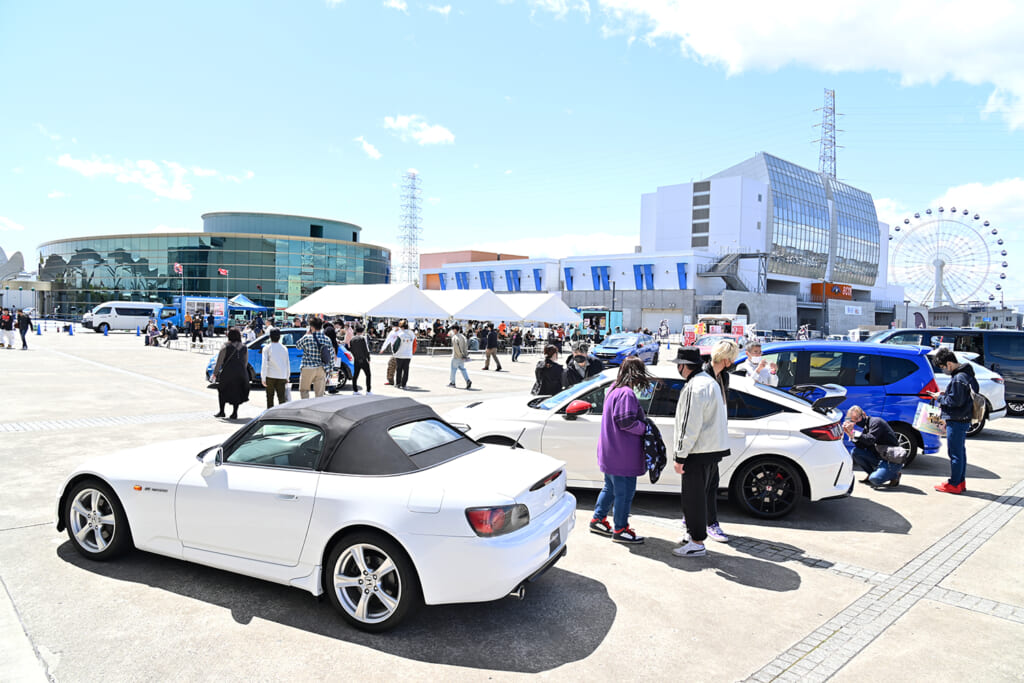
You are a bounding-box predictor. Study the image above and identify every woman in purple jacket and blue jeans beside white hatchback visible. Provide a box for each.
[590,357,651,543]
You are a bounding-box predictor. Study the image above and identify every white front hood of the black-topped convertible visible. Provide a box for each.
[74,436,224,484]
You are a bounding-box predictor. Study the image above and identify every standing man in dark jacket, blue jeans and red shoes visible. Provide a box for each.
[932,348,979,494]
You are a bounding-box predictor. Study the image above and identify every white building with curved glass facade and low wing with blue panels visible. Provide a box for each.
[421,153,903,332]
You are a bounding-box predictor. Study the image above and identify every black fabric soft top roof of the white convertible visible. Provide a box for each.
[260,395,477,475]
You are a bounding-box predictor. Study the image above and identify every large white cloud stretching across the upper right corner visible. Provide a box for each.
[529,0,1024,129]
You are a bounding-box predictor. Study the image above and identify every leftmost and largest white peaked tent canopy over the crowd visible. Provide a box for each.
[287,284,447,318]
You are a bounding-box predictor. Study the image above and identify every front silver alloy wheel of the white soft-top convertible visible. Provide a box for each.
[65,480,130,560]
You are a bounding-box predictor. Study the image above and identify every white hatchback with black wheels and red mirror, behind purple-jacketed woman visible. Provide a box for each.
[444,366,853,518]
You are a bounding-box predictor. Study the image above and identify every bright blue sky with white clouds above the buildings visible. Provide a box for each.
[0,0,1024,303]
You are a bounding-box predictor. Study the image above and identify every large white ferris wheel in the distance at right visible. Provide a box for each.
[889,207,1010,306]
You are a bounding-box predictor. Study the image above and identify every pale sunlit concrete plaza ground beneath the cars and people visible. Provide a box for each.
[0,332,1024,681]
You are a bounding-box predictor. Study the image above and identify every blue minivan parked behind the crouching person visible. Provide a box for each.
[740,341,941,464]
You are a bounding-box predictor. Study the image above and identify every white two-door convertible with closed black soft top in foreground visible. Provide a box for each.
[57,396,575,631]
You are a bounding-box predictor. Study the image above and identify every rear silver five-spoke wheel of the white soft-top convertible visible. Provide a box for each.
[326,533,420,632]
